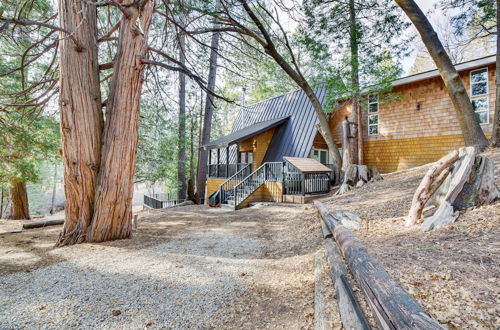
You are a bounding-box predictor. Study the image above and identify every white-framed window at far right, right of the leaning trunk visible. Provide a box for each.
[470,68,489,124]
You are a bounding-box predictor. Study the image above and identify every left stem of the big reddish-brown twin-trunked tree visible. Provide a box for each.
[58,0,103,245]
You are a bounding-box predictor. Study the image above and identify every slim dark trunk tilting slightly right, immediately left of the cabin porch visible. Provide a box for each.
[196,32,220,201]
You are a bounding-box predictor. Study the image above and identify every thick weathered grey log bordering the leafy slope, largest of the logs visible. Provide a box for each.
[314,201,444,329]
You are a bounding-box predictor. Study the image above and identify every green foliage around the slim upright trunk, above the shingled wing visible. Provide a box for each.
[297,0,410,111]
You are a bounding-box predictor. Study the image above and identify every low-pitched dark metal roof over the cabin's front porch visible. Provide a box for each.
[203,116,289,149]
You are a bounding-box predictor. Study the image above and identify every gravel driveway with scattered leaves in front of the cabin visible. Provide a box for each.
[0,206,321,329]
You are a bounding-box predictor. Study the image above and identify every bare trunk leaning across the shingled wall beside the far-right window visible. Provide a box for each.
[395,0,488,148]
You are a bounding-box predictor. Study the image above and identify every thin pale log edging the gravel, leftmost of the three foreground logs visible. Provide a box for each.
[314,250,332,330]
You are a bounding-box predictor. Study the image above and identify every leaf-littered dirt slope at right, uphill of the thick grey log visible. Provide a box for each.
[324,151,500,329]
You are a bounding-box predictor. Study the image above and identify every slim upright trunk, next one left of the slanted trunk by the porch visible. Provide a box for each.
[177,32,186,199]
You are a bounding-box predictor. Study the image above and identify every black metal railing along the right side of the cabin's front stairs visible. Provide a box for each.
[234,162,283,207]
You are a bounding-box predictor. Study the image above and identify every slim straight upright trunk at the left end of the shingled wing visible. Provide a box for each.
[349,0,360,164]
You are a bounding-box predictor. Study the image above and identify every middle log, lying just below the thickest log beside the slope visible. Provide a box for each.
[325,238,370,329]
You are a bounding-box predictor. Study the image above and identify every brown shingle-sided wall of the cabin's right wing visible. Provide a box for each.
[330,65,495,173]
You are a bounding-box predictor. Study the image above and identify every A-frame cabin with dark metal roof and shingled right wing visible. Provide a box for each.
[203,56,496,209]
